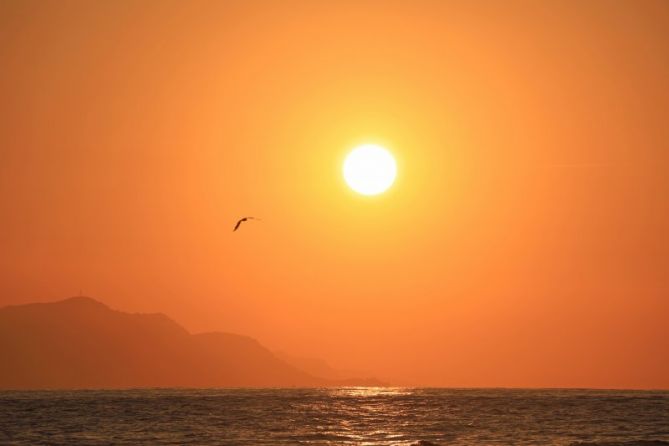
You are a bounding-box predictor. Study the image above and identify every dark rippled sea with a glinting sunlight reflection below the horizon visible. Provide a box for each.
[0,388,669,446]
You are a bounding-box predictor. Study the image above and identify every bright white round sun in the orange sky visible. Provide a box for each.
[343,144,397,195]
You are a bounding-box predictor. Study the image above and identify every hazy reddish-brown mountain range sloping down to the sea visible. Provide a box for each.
[0,296,382,389]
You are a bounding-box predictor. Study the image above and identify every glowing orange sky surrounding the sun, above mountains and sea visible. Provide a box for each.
[0,0,669,388]
